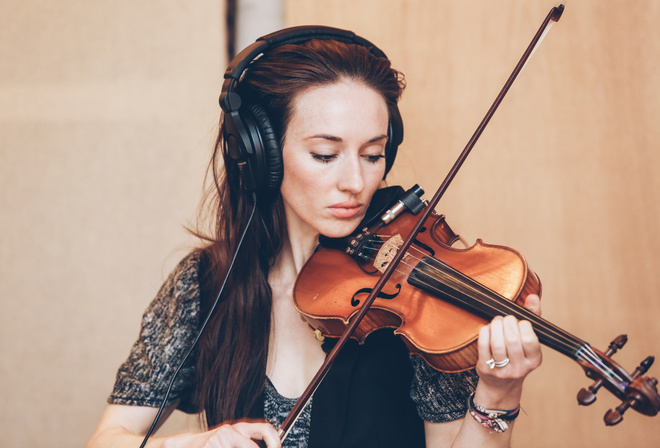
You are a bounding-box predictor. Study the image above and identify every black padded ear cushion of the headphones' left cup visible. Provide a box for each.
[247,104,284,190]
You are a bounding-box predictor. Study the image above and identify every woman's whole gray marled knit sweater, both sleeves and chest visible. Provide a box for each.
[108,253,478,447]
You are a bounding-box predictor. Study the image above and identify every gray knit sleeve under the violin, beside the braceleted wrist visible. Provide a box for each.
[410,355,479,423]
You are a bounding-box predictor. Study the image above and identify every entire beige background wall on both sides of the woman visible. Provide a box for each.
[0,0,660,448]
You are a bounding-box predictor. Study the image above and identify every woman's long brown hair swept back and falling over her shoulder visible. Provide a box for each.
[194,39,404,427]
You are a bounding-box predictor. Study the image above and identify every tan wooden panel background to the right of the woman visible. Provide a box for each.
[287,0,660,448]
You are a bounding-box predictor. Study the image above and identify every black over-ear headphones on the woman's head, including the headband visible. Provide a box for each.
[220,26,403,191]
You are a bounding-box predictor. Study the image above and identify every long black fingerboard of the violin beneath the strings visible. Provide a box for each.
[408,257,591,360]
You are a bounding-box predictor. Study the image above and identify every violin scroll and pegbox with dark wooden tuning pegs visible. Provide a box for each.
[577,335,660,426]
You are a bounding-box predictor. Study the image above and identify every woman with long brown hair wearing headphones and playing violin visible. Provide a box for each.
[88,30,541,448]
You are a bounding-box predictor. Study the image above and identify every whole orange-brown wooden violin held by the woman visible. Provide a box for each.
[294,182,660,425]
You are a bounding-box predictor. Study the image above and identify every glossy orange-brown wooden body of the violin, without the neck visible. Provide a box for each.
[294,212,541,372]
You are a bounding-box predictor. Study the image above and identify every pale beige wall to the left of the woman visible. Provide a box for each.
[0,0,225,448]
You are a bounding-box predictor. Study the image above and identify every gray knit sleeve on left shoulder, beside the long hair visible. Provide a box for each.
[108,253,200,412]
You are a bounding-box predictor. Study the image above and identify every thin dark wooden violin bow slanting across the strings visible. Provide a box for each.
[278,5,564,441]
